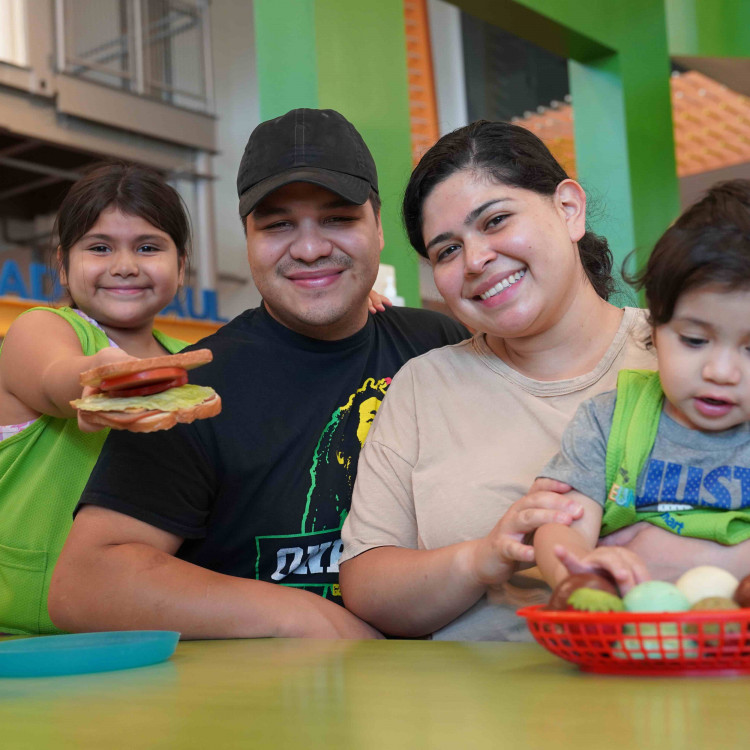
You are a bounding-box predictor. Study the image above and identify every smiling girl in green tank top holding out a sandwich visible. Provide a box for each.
[0,164,190,634]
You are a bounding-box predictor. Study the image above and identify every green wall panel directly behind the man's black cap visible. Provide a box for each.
[253,0,420,306]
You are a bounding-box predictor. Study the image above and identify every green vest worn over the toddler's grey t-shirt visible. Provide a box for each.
[600,370,750,544]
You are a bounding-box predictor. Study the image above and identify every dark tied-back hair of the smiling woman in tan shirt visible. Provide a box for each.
[402,120,615,299]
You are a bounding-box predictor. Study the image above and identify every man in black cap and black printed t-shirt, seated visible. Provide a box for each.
[49,109,467,638]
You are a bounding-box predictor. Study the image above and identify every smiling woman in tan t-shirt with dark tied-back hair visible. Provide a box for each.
[341,122,654,640]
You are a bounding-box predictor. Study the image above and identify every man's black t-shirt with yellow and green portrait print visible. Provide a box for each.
[79,307,468,602]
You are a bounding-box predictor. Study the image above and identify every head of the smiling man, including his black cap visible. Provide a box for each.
[237,109,390,340]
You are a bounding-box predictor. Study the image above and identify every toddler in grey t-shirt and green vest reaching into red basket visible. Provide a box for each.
[534,180,750,593]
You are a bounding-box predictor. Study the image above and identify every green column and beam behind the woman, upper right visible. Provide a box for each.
[454,0,679,286]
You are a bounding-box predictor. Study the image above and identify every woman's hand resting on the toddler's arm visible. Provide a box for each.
[471,478,583,587]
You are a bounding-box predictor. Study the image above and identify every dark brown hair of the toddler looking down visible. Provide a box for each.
[627,180,750,327]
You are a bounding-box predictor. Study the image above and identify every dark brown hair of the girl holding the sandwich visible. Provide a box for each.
[53,162,190,272]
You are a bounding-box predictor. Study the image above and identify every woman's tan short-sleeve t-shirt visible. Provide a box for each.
[341,308,656,640]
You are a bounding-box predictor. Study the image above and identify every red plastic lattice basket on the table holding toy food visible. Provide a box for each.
[518,605,750,675]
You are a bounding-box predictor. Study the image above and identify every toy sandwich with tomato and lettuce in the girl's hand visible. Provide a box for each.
[70,349,221,432]
